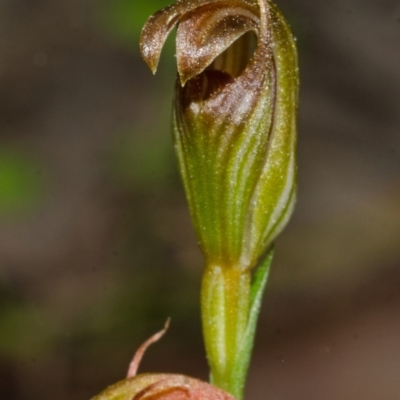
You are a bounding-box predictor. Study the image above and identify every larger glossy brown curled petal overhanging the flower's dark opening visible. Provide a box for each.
[176,0,259,85]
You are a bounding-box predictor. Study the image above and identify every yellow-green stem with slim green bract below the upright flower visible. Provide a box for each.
[201,251,272,399]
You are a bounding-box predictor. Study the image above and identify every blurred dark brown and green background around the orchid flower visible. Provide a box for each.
[0,0,400,400]
